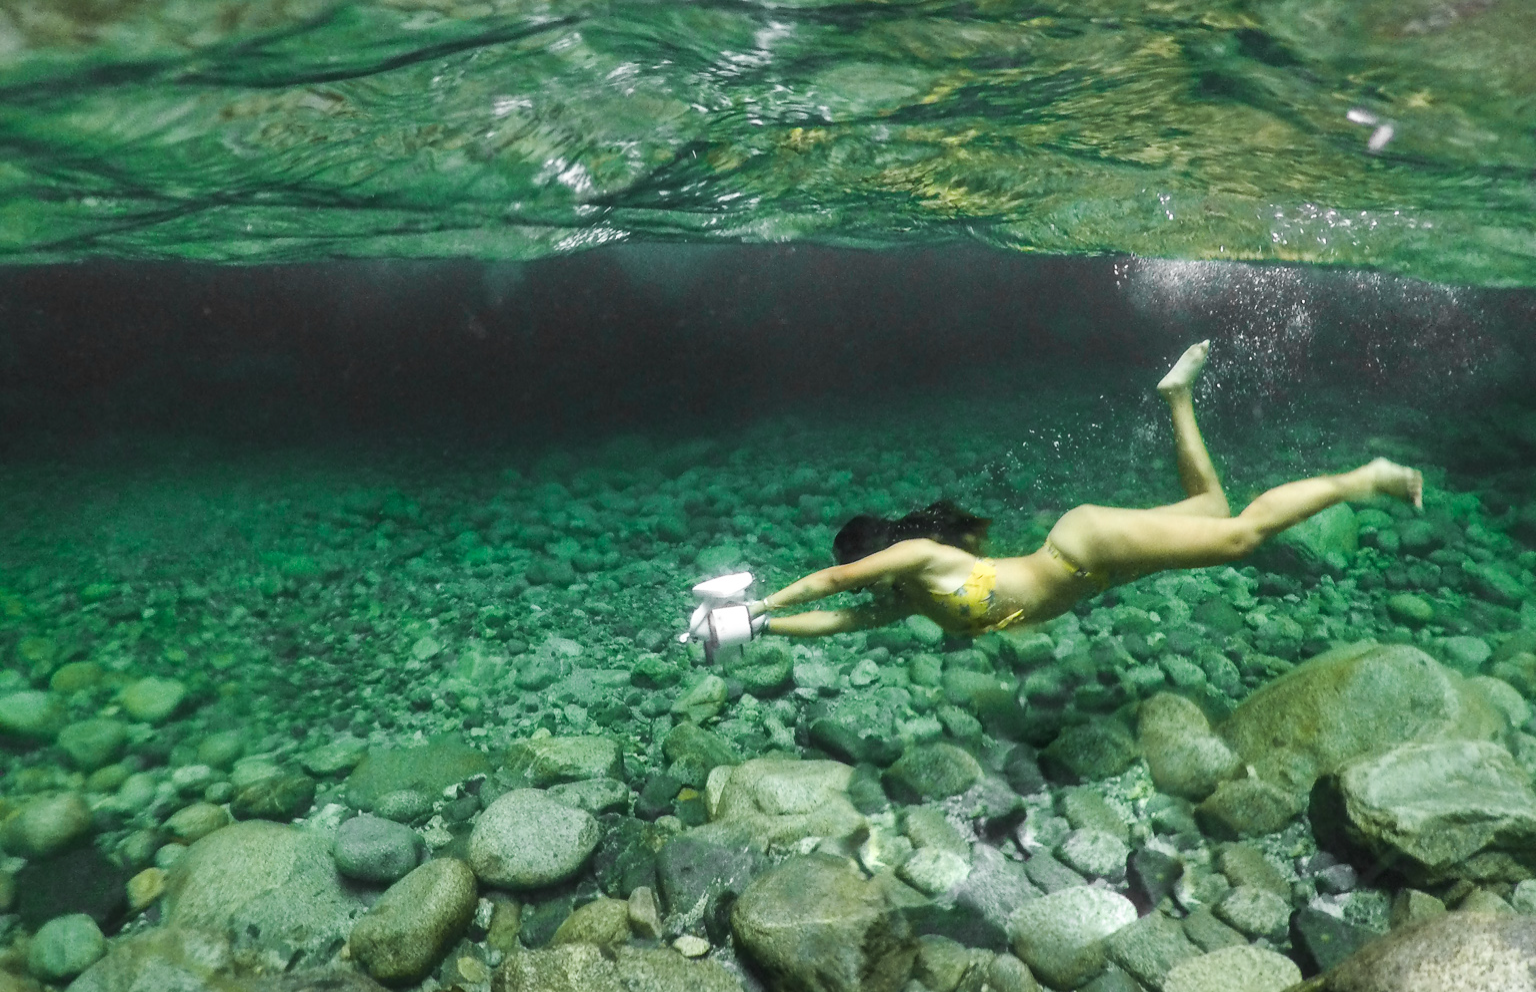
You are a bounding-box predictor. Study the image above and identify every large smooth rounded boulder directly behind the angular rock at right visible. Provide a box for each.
[1217,642,1507,795]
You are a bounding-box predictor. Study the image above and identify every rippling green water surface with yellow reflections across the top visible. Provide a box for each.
[0,0,1536,286]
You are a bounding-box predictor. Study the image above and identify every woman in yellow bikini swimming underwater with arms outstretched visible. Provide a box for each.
[748,341,1424,637]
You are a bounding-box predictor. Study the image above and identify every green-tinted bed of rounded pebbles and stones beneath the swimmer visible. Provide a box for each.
[0,380,1536,992]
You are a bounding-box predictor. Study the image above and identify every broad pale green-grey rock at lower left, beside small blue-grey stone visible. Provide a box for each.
[163,820,362,960]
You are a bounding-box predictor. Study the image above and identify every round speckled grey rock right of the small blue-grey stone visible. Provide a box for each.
[468,789,601,889]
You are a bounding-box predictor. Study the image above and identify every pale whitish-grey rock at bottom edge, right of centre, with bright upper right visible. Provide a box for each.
[1009,886,1137,989]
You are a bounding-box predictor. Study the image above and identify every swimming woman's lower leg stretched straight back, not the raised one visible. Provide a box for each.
[1049,458,1424,576]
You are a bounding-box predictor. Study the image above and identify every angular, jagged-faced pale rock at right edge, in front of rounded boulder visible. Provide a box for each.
[1336,740,1536,885]
